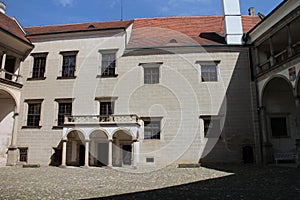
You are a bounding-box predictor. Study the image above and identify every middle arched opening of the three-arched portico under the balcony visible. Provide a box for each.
[90,130,109,167]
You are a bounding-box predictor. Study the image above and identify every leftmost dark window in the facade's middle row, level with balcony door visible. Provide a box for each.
[27,103,41,127]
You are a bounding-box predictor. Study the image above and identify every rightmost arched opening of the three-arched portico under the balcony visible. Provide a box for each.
[112,130,133,167]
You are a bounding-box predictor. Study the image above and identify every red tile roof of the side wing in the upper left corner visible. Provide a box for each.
[0,12,30,43]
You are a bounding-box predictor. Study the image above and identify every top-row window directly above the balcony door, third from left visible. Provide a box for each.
[101,53,116,77]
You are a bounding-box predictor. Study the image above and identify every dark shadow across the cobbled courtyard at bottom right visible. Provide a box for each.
[84,165,300,200]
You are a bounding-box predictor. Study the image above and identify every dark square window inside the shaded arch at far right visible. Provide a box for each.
[270,116,288,137]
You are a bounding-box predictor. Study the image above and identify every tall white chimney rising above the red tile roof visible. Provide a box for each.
[223,0,243,45]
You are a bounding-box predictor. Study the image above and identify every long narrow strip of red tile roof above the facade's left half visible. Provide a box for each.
[25,20,133,36]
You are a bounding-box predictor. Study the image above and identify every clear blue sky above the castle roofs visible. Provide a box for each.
[3,0,283,27]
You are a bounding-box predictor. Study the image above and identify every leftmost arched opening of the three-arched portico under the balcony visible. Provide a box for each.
[66,131,85,166]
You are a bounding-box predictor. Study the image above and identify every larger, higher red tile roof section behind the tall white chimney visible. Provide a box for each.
[128,16,260,48]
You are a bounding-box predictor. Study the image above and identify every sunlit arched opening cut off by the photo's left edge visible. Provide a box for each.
[0,90,16,165]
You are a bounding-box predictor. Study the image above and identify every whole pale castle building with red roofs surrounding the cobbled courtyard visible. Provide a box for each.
[0,0,299,167]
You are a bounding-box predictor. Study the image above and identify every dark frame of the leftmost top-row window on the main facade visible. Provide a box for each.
[27,52,48,81]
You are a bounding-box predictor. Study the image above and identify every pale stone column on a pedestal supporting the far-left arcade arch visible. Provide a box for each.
[6,113,19,166]
